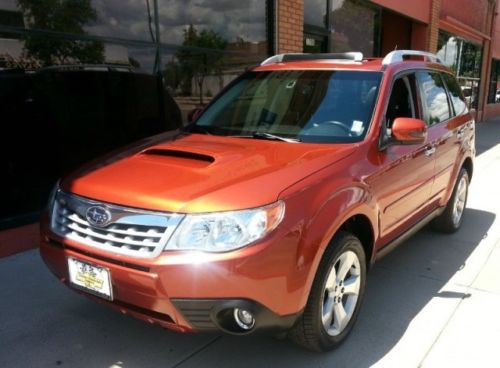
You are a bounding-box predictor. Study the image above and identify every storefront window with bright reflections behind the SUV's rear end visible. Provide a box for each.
[437,31,483,109]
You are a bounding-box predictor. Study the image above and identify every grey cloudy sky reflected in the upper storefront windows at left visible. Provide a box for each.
[86,0,266,44]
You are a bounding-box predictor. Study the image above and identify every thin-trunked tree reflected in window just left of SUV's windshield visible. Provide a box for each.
[176,24,227,105]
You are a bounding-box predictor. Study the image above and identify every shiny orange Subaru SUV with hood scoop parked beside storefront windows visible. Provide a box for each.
[40,51,475,351]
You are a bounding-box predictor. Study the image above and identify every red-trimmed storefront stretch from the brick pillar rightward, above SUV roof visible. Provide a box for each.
[275,0,500,120]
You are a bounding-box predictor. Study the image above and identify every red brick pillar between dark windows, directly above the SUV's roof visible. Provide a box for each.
[277,0,307,53]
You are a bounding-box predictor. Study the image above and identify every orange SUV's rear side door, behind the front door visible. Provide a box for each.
[426,73,473,201]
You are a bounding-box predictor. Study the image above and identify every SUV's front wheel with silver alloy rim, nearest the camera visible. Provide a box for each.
[289,231,366,352]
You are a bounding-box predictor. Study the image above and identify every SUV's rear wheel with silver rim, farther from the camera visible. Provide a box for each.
[432,168,469,233]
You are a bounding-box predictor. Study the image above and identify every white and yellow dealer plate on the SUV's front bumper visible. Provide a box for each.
[68,257,113,300]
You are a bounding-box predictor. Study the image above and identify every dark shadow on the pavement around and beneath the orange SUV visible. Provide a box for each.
[0,209,495,368]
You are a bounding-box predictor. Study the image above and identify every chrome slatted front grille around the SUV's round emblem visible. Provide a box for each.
[51,191,184,258]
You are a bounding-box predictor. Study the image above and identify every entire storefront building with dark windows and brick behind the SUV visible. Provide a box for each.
[0,0,500,224]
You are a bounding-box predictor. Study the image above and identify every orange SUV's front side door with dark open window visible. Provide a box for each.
[367,73,435,243]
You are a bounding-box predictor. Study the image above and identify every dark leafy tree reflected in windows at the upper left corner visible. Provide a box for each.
[18,0,104,66]
